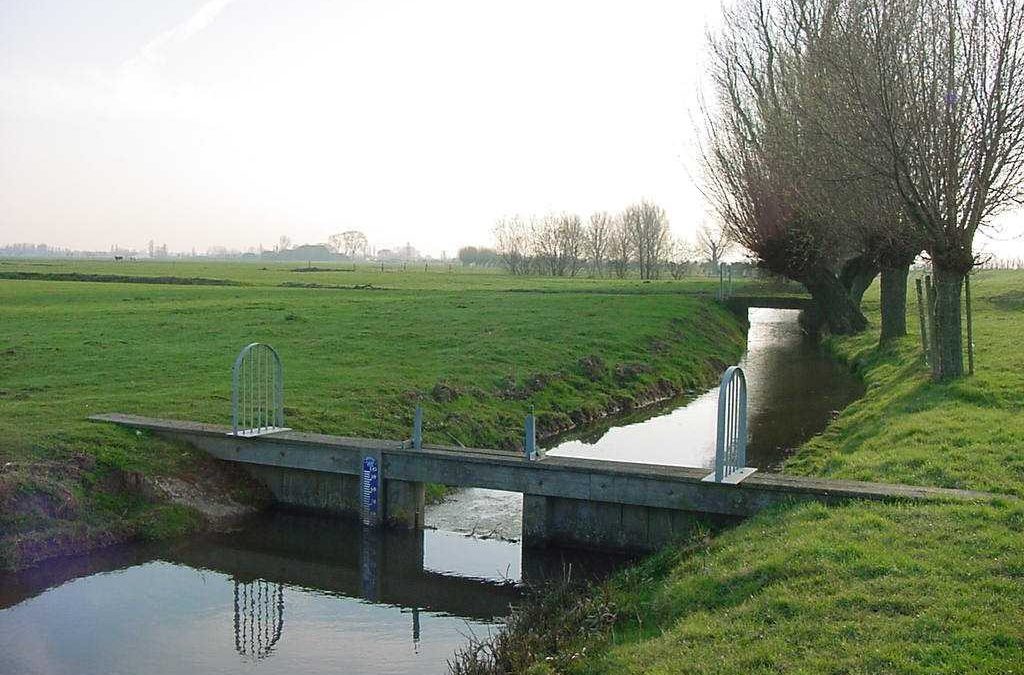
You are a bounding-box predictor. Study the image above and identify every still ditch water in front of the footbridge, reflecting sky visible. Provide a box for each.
[0,512,625,675]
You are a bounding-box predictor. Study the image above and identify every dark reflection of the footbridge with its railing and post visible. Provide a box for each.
[182,513,623,660]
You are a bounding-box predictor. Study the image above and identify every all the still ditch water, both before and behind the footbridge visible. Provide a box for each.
[0,310,861,675]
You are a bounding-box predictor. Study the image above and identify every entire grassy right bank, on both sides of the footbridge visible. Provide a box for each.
[467,272,1024,674]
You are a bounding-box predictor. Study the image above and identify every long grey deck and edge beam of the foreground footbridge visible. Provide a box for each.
[89,413,996,516]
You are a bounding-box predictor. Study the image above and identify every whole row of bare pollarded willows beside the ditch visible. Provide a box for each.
[702,0,1024,379]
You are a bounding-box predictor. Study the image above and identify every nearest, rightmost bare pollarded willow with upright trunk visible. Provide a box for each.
[822,0,1024,379]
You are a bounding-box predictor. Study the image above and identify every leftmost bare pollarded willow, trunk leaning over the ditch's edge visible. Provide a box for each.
[702,0,867,334]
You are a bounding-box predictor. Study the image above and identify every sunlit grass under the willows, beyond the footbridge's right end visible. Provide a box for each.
[786,271,1024,497]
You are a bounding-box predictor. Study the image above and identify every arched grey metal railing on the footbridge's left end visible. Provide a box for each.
[231,342,286,436]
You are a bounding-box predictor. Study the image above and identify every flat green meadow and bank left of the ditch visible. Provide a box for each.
[0,261,743,567]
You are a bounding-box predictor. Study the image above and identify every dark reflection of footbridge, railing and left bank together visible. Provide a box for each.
[0,513,623,662]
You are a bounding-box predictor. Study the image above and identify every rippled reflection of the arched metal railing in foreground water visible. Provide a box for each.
[234,579,285,660]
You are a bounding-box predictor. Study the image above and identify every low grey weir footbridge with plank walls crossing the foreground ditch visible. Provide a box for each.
[90,414,992,551]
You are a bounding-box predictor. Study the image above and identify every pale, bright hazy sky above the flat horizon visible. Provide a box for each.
[0,0,1024,255]
